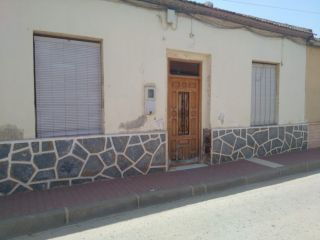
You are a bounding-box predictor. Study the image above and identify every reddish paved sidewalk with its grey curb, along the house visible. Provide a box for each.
[0,149,320,239]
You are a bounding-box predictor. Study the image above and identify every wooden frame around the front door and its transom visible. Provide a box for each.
[167,57,203,167]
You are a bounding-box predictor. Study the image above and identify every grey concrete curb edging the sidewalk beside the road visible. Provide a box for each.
[0,160,320,239]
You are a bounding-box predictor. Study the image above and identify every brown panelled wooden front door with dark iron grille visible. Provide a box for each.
[168,75,201,163]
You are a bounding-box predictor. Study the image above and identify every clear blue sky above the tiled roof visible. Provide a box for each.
[194,0,320,38]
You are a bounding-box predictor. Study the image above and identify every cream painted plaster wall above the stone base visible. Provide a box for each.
[0,0,306,138]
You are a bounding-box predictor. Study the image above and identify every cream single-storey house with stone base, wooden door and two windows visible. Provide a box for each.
[0,0,319,194]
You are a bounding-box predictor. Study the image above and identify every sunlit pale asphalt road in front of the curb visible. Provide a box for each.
[16,172,320,240]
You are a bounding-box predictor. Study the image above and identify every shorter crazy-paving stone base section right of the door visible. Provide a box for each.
[210,124,308,164]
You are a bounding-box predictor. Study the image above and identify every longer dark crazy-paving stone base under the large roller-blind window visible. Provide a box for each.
[0,133,167,195]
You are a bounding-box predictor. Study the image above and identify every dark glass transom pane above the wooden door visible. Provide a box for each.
[170,61,200,76]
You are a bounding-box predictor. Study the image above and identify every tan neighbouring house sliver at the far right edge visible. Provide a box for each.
[306,40,320,148]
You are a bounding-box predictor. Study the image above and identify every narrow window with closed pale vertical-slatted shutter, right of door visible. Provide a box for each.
[251,63,278,126]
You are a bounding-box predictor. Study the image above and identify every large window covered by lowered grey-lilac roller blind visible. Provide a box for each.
[34,36,103,137]
